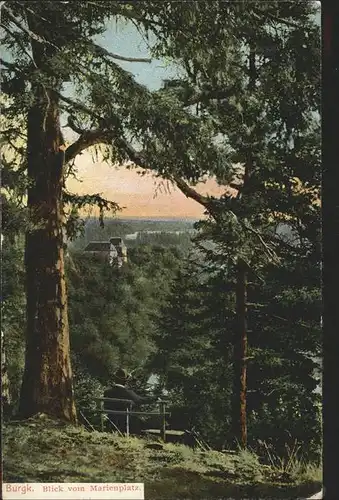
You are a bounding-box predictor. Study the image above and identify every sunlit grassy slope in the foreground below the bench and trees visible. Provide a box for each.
[3,416,321,500]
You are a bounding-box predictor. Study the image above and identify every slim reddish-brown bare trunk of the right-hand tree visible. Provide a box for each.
[232,259,247,448]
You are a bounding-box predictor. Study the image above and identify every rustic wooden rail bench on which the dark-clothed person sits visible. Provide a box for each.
[88,398,171,441]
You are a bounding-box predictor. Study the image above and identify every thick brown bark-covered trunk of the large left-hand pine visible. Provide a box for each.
[19,86,76,422]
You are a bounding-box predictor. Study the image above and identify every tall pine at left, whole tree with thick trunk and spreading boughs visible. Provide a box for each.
[1,1,234,421]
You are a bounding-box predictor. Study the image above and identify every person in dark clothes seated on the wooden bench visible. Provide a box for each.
[104,368,158,434]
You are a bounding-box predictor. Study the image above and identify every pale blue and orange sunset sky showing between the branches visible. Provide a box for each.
[66,23,228,218]
